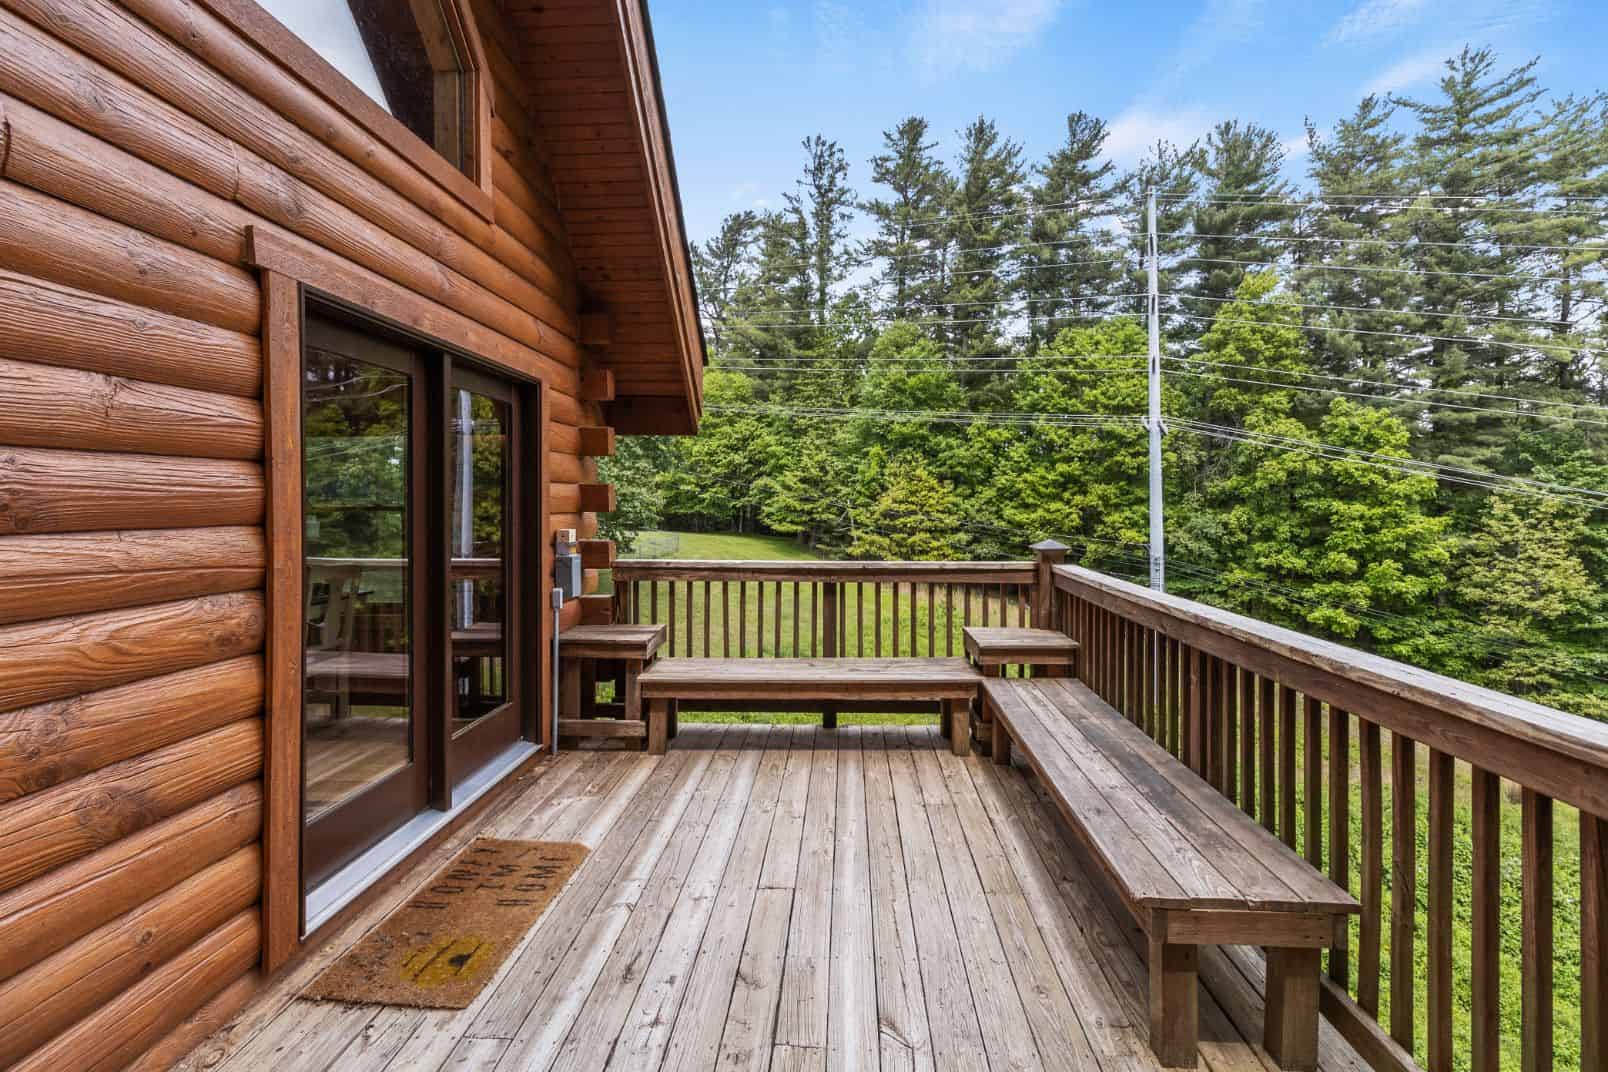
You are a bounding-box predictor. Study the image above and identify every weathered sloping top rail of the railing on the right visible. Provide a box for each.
[1055,566,1608,797]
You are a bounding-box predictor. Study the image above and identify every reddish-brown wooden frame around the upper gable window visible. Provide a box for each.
[199,0,494,222]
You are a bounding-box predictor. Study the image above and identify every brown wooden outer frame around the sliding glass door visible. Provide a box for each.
[246,227,558,972]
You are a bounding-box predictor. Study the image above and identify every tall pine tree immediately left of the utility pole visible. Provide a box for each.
[1018,111,1134,342]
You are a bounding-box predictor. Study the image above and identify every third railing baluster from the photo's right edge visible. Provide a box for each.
[1470,767,1502,1072]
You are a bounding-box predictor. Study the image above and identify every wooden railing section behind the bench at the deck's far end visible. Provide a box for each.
[613,559,1036,659]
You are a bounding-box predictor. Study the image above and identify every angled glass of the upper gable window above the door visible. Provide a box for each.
[259,0,474,178]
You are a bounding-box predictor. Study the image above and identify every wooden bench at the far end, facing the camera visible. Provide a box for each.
[638,659,982,755]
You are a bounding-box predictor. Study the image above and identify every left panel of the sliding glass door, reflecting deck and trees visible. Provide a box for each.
[302,320,428,882]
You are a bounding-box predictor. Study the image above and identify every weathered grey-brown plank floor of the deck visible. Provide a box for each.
[180,725,1364,1072]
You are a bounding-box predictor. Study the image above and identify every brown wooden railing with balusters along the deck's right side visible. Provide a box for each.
[1052,566,1608,1072]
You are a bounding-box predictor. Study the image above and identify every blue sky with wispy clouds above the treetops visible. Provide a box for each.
[651,0,1608,239]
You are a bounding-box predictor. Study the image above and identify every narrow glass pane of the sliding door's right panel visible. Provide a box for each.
[447,386,513,738]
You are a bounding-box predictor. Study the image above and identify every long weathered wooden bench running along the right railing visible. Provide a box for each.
[982,678,1360,1069]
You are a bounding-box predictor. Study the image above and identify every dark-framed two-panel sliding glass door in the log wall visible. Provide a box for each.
[302,315,539,889]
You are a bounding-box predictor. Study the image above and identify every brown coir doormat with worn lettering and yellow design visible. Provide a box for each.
[302,837,587,1009]
